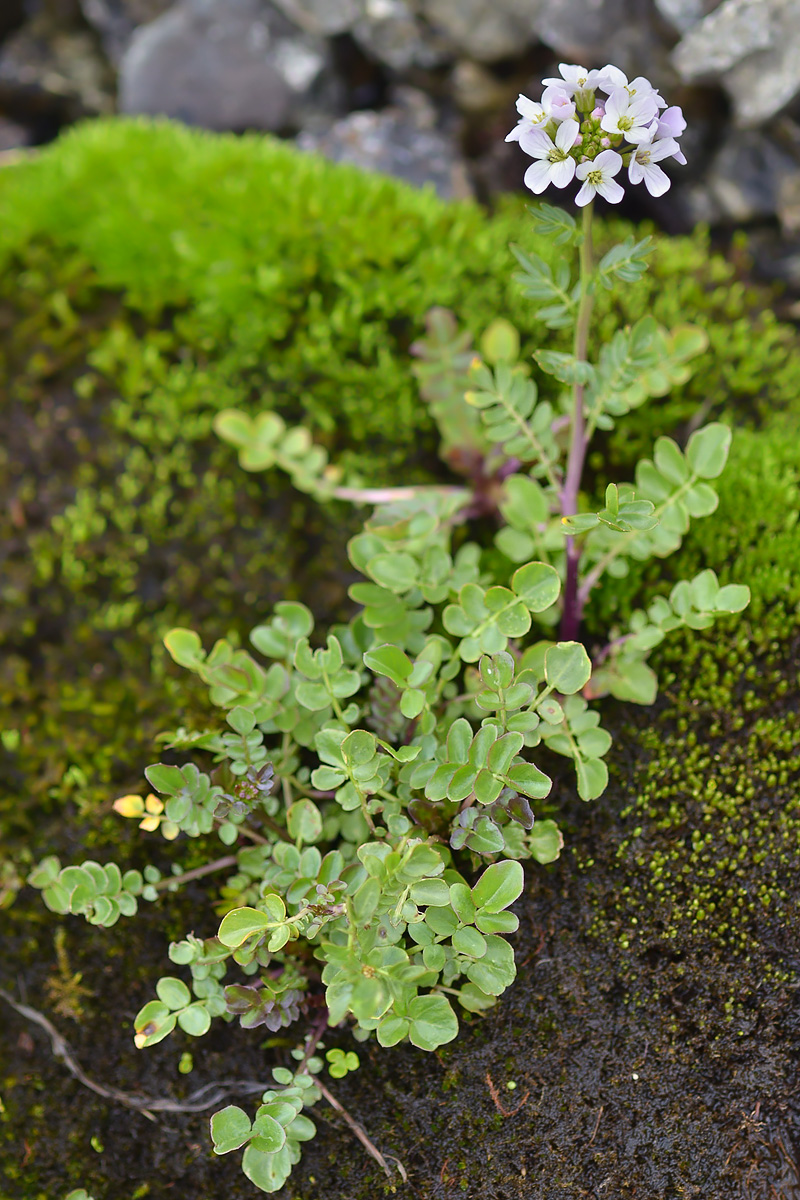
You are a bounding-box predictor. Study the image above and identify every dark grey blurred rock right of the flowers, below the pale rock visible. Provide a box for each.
[685,130,800,224]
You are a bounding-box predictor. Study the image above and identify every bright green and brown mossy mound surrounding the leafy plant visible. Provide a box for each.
[0,114,800,1200]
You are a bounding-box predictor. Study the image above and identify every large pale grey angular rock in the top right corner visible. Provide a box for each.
[673,0,800,126]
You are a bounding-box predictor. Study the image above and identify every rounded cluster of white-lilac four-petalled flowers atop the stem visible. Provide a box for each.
[506,62,686,206]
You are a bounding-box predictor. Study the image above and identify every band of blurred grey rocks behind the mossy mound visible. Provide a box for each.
[0,0,800,288]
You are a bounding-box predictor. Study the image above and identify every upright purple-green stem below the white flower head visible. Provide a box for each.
[560,202,594,642]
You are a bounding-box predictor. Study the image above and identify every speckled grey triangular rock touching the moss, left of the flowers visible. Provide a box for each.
[296,88,471,199]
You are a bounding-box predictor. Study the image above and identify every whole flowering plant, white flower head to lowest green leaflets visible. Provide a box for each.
[23,65,748,1192]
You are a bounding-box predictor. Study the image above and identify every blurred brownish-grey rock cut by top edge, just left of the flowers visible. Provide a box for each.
[420,0,544,62]
